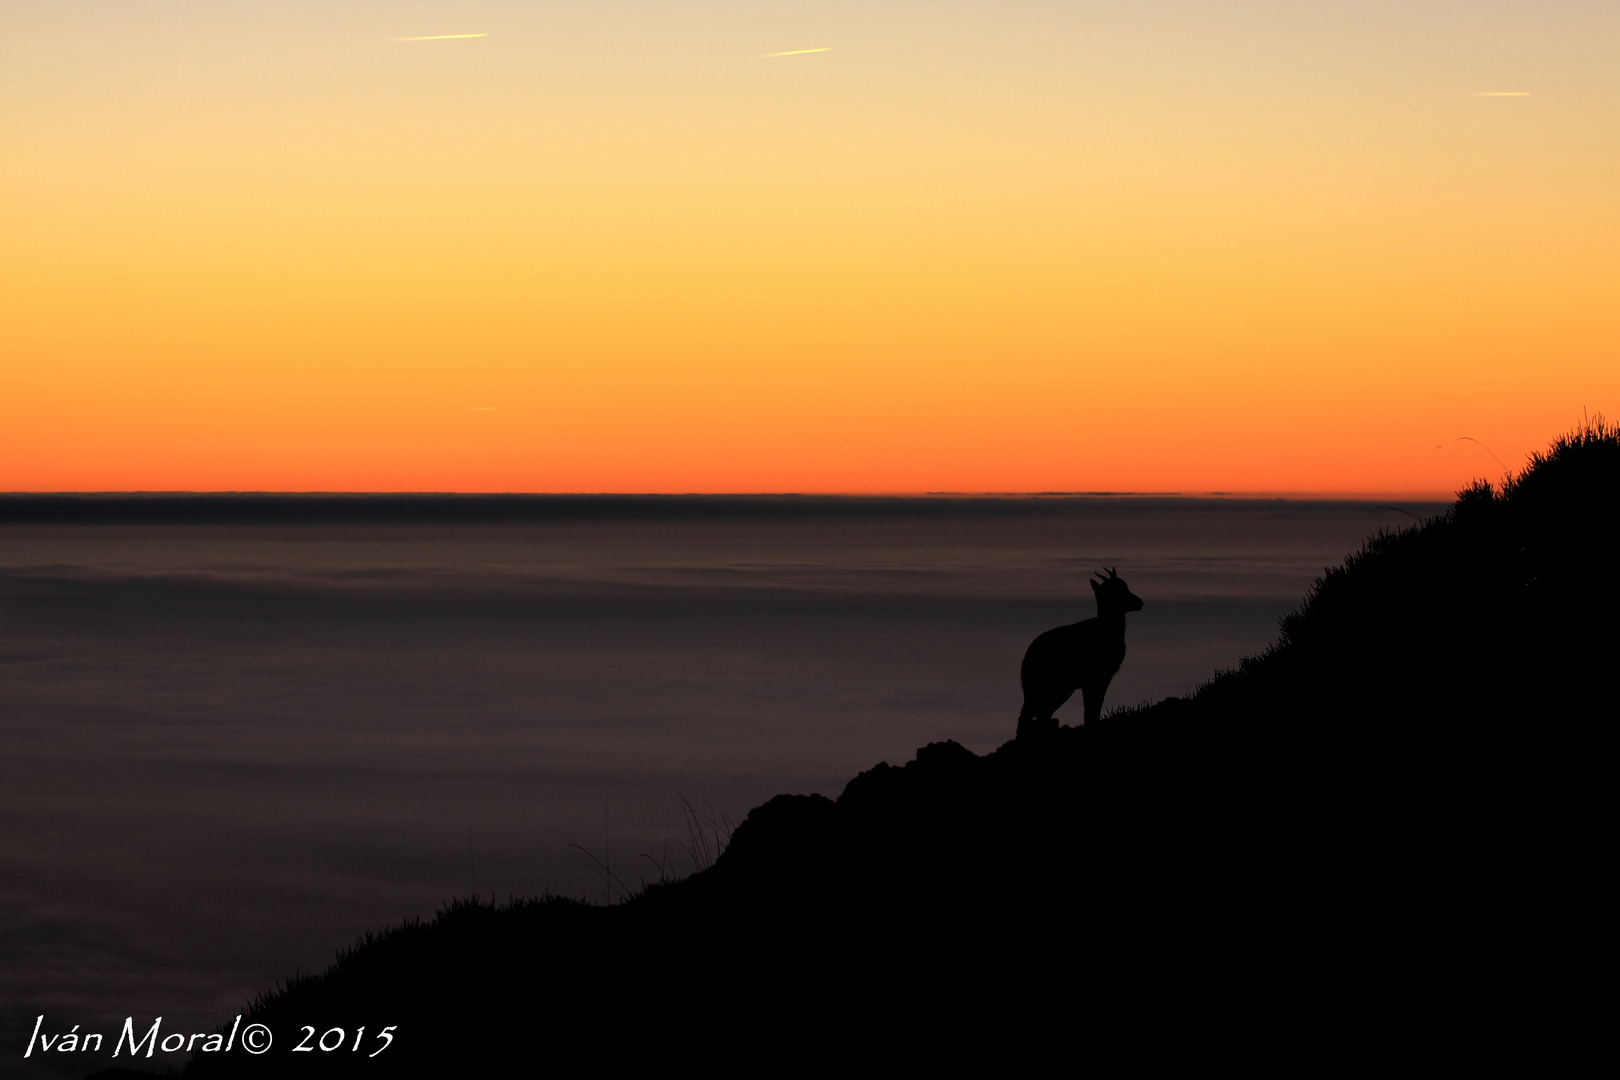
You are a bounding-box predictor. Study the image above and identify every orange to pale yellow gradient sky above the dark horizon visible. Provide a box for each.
[0,0,1620,492]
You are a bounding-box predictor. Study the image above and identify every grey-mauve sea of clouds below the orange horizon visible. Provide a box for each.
[0,499,1440,1072]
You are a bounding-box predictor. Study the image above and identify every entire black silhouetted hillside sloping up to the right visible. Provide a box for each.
[170,424,1620,1078]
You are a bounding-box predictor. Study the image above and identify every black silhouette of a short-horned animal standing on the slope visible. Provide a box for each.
[1017,570,1142,738]
